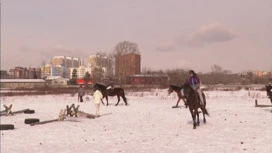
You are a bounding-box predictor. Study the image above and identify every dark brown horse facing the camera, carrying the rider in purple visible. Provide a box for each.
[182,84,209,129]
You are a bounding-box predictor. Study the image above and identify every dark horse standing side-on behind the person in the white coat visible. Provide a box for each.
[94,83,127,106]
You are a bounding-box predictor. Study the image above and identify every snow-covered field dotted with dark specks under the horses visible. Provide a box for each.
[1,89,272,153]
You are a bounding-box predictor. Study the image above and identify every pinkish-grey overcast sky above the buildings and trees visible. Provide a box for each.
[1,0,272,72]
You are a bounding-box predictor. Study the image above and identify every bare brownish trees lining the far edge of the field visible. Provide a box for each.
[68,41,272,85]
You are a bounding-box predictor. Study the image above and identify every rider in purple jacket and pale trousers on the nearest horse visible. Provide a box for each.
[187,70,204,105]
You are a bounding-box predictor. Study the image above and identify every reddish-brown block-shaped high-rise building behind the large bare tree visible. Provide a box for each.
[115,53,141,79]
